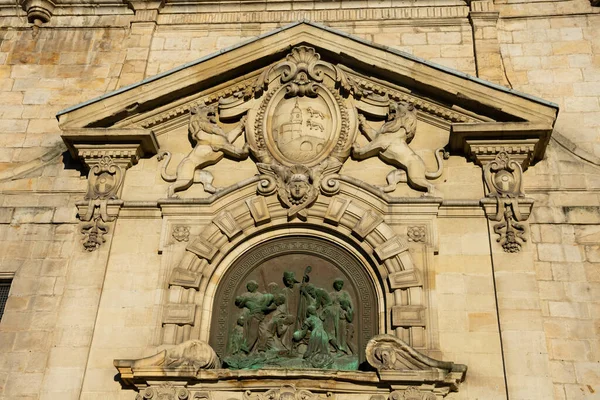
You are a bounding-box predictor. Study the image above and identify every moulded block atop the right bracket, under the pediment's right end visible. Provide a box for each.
[449,122,552,170]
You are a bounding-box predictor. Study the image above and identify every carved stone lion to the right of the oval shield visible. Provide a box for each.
[352,102,444,196]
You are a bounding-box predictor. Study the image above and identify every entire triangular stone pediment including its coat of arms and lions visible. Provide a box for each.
[57,18,558,208]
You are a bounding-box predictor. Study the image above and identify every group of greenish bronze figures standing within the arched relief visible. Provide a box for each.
[223,266,358,370]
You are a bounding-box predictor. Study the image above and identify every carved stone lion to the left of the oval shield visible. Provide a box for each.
[158,105,248,197]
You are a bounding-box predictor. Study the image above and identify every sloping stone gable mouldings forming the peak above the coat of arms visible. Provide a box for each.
[58,22,557,129]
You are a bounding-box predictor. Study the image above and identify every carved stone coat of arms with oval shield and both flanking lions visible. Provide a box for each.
[159,46,445,208]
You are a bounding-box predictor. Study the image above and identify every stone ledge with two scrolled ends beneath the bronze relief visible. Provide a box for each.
[114,335,467,400]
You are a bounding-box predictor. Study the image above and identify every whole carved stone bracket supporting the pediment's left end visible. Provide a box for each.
[61,129,158,251]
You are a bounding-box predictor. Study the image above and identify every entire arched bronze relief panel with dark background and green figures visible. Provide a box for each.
[211,236,377,370]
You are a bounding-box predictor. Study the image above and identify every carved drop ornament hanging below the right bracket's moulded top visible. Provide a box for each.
[483,152,527,253]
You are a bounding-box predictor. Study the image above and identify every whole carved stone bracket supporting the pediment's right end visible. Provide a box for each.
[450,122,552,253]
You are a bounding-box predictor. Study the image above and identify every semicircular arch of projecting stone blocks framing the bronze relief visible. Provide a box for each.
[162,188,425,354]
